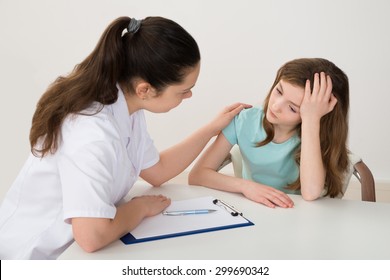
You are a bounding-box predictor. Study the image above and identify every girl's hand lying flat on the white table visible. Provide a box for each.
[242,182,294,208]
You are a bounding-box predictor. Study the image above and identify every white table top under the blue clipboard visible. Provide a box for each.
[59,182,390,260]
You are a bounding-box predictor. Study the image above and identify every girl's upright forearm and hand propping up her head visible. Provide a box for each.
[300,72,337,200]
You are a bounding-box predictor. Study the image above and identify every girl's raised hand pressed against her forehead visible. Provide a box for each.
[300,72,337,121]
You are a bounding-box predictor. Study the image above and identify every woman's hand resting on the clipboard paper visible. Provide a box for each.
[132,194,171,217]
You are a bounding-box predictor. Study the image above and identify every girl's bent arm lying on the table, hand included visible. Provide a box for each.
[188,133,294,208]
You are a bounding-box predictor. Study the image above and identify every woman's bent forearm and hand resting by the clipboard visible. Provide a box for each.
[72,195,171,253]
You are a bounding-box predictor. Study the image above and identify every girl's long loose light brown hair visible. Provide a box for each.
[257,58,349,197]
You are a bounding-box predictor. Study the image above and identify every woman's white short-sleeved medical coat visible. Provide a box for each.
[0,86,159,259]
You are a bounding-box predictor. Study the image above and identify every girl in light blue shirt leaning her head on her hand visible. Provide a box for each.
[189,58,349,208]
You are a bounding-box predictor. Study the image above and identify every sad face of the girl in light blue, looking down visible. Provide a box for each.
[266,80,305,129]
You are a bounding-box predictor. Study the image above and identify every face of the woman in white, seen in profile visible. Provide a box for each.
[147,63,200,113]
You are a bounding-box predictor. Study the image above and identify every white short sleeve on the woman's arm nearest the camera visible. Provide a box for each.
[58,117,120,223]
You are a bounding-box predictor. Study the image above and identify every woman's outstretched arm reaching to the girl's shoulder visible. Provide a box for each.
[141,103,251,186]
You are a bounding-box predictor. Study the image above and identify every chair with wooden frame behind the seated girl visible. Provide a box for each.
[218,145,376,202]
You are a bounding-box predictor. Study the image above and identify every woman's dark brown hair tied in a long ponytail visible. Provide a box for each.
[30,17,200,157]
